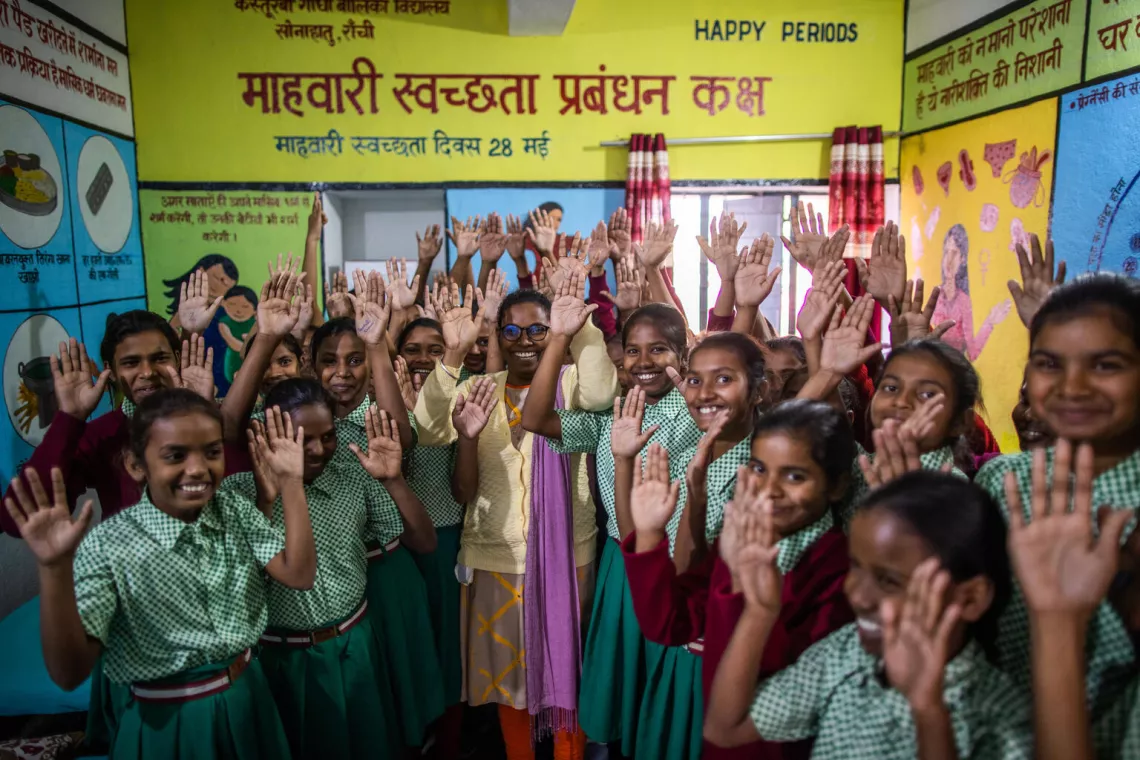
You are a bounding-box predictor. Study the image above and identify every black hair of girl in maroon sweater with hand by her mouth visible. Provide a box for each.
[752,399,855,487]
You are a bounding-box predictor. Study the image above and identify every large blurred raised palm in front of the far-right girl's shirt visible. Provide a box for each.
[1004,439,1135,619]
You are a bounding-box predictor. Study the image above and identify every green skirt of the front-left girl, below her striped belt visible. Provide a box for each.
[111,657,291,760]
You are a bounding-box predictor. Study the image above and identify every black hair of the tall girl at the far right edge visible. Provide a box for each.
[1029,272,1140,348]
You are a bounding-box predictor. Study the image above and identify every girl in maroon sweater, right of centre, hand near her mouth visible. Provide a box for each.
[626,401,855,760]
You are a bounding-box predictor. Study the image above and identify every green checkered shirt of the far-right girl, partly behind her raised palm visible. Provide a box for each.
[975,448,1140,738]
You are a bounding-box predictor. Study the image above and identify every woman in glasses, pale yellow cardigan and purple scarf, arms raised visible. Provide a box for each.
[416,278,618,758]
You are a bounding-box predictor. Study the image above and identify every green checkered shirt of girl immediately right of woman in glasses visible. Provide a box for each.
[548,389,702,541]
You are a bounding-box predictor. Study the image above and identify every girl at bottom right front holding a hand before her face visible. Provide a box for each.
[705,471,1032,760]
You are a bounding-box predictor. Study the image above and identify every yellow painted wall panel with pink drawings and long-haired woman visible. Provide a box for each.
[899,98,1057,451]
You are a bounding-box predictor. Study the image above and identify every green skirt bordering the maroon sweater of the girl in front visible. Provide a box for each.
[634,641,705,760]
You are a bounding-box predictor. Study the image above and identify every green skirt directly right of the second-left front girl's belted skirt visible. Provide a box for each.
[367,546,445,747]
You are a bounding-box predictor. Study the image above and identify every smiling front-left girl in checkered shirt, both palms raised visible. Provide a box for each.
[6,389,316,759]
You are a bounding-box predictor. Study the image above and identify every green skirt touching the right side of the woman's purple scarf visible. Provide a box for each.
[578,539,646,757]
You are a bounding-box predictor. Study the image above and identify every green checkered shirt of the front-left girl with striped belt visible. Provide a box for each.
[75,487,285,684]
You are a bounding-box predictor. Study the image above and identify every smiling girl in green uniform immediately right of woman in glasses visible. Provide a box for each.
[522,279,700,755]
